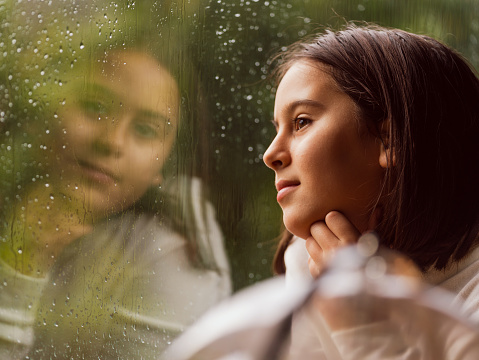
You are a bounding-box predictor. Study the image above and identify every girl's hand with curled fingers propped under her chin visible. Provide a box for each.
[306,211,361,278]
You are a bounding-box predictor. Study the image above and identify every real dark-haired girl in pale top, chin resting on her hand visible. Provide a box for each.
[166,25,479,360]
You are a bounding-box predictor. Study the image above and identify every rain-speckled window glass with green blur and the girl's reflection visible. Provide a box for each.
[0,0,479,359]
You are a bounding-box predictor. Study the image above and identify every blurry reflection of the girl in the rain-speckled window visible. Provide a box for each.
[0,9,230,359]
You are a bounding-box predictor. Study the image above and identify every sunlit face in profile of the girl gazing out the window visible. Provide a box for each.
[264,60,384,239]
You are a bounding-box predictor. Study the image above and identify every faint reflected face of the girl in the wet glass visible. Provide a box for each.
[56,51,179,215]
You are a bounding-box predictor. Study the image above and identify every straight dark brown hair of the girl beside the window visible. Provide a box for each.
[274,25,479,273]
